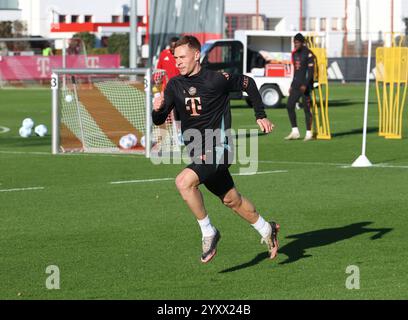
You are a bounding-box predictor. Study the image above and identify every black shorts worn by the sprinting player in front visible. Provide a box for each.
[187,163,234,200]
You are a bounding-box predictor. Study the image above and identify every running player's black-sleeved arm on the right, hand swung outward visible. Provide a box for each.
[224,74,274,133]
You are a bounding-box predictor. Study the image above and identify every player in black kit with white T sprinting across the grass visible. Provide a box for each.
[152,36,279,263]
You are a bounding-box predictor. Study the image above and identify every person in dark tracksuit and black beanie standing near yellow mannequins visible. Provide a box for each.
[285,33,315,141]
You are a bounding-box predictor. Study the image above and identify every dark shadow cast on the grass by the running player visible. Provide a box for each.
[219,221,393,273]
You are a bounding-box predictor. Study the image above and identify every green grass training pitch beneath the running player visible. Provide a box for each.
[0,84,408,299]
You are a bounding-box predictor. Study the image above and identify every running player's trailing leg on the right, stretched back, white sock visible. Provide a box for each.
[204,169,279,259]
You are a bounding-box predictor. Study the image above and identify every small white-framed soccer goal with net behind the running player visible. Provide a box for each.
[51,68,177,157]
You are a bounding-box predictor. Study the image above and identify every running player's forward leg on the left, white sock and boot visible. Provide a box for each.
[176,164,221,263]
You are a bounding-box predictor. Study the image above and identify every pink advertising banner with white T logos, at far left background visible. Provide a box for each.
[0,54,120,81]
